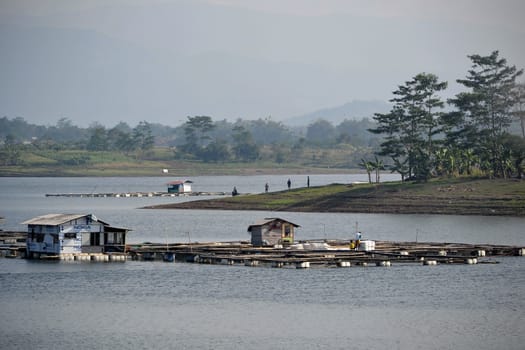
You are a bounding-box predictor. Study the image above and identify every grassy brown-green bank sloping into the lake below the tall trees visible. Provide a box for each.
[143,178,525,216]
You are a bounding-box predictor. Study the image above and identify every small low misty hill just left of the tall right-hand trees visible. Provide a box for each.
[284,100,391,126]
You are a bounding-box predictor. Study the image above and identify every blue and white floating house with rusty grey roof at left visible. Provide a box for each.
[22,214,129,258]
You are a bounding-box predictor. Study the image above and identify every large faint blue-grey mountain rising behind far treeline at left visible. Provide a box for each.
[0,23,352,126]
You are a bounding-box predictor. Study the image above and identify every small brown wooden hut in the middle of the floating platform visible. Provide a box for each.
[248,218,300,247]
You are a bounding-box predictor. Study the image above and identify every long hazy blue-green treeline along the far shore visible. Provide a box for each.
[0,116,380,166]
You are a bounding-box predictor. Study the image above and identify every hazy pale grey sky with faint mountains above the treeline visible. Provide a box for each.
[0,0,525,126]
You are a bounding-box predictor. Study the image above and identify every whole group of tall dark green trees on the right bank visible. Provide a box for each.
[370,51,525,181]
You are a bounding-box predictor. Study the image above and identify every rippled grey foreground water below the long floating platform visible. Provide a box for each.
[0,258,525,349]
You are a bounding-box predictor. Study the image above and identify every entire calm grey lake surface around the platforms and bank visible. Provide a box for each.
[0,174,525,349]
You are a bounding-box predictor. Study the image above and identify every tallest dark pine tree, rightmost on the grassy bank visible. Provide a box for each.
[447,51,523,177]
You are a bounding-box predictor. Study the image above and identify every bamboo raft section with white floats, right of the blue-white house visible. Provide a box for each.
[125,240,525,268]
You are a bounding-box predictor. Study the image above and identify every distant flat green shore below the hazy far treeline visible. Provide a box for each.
[0,148,356,177]
